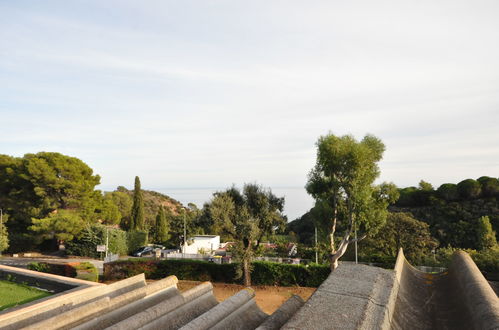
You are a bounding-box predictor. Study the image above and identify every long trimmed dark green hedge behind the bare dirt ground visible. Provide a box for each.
[104,259,330,287]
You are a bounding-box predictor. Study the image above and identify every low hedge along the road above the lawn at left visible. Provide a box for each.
[28,261,99,282]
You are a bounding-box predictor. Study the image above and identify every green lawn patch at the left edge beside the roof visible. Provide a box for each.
[0,281,51,311]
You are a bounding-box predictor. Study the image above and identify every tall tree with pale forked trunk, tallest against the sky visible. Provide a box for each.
[306,134,398,270]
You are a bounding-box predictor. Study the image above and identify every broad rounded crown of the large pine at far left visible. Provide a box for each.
[0,152,101,251]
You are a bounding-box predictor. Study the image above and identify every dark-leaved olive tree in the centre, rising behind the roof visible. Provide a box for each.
[207,184,284,286]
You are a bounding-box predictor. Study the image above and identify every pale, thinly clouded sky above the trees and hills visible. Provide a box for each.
[0,0,499,219]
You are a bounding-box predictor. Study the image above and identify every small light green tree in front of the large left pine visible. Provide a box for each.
[29,209,85,244]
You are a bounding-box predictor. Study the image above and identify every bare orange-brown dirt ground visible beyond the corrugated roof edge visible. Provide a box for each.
[177,280,316,314]
